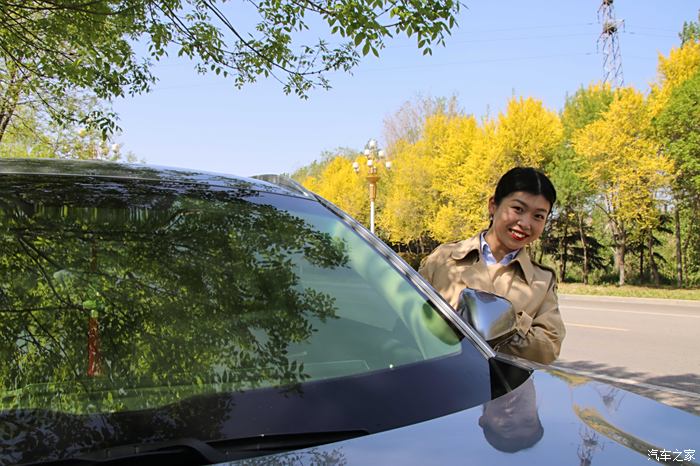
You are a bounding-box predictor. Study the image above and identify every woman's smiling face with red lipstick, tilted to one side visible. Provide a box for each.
[489,191,552,253]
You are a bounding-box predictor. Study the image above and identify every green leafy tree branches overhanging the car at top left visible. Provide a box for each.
[0,0,461,132]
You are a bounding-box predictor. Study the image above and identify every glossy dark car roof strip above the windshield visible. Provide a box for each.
[0,158,310,198]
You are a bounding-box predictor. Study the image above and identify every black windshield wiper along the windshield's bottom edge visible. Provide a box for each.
[30,430,369,466]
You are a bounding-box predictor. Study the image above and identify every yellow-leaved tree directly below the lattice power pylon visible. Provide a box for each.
[573,88,673,285]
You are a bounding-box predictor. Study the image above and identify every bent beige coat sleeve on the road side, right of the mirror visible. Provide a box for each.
[496,274,566,364]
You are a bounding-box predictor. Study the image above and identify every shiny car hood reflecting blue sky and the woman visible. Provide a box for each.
[232,369,700,466]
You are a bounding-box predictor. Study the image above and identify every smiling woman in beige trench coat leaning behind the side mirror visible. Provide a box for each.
[419,167,566,364]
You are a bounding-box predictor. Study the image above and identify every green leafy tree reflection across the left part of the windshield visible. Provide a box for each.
[0,180,347,413]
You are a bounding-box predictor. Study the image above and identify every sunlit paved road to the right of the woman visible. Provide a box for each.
[555,295,700,415]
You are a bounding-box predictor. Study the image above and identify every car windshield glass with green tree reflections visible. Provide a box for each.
[0,177,488,460]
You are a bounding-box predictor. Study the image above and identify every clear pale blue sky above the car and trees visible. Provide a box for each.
[115,0,700,175]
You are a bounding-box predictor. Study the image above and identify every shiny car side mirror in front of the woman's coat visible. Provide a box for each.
[457,288,517,347]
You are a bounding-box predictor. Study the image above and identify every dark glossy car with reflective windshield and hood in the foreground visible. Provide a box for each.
[0,159,700,465]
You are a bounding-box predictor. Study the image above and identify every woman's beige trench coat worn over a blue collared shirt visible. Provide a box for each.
[418,235,566,364]
